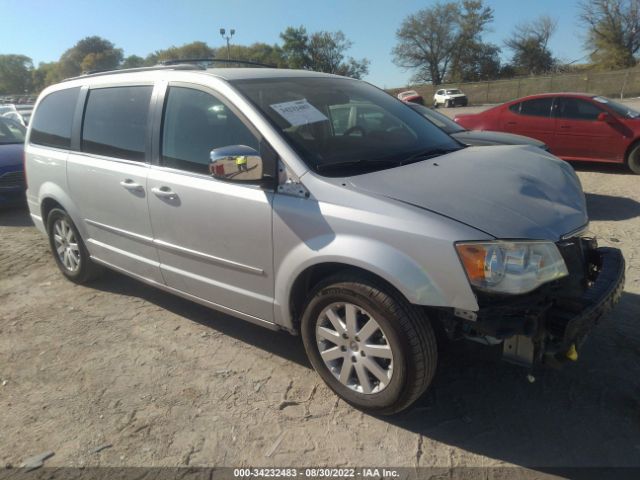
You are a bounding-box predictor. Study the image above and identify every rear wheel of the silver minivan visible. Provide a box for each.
[47,208,103,284]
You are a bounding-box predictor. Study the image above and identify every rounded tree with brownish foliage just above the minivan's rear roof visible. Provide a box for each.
[59,36,123,78]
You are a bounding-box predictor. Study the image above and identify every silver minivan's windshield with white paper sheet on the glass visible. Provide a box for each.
[232,77,461,176]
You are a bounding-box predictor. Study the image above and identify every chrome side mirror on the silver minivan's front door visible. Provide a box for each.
[209,145,264,183]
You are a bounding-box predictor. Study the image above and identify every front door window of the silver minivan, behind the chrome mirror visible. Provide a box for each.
[161,87,260,174]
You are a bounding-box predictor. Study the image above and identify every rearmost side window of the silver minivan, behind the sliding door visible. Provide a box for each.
[29,87,80,148]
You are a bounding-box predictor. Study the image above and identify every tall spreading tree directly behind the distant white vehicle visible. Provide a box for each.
[393,3,460,85]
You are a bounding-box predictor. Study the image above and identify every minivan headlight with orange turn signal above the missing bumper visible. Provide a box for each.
[456,241,569,294]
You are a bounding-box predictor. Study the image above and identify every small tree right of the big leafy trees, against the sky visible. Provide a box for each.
[504,15,557,75]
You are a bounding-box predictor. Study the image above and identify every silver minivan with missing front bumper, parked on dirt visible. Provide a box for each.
[25,64,624,414]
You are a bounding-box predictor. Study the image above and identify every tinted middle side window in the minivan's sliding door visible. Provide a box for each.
[82,85,153,162]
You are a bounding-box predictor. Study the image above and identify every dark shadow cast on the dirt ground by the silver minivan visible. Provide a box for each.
[93,272,640,471]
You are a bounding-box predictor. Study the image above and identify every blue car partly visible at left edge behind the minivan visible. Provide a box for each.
[0,117,26,207]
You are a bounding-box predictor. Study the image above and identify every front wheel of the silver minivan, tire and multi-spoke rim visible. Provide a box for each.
[301,274,438,415]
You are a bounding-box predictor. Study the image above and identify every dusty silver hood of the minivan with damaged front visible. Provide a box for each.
[349,146,588,241]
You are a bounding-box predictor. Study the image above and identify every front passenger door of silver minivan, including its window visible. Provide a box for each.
[147,84,274,321]
